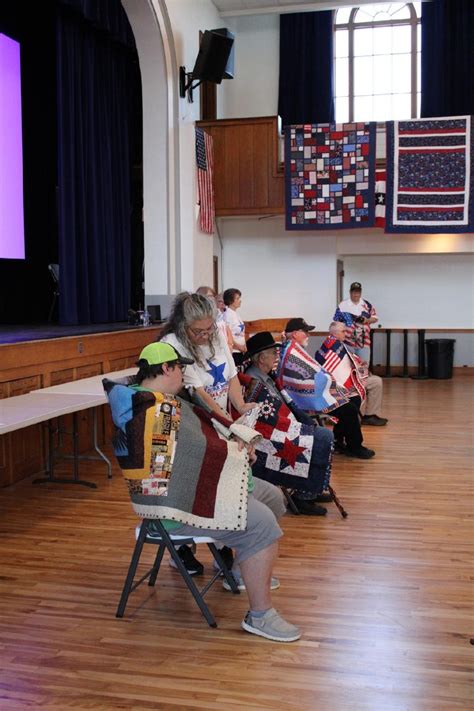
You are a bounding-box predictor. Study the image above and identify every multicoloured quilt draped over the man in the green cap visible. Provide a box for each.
[104,380,248,531]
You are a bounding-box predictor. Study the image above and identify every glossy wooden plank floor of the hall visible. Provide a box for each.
[0,377,474,711]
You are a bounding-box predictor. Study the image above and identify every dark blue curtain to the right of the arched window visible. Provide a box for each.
[421,0,474,117]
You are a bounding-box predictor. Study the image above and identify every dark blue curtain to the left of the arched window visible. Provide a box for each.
[278,10,334,126]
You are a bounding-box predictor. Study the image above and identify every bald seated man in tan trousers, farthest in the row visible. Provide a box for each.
[314,321,388,427]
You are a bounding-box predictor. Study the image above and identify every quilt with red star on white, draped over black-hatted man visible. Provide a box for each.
[239,373,333,494]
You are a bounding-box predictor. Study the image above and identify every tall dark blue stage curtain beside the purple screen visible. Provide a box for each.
[57,0,136,325]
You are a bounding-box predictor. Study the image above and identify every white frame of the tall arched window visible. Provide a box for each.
[333,2,421,123]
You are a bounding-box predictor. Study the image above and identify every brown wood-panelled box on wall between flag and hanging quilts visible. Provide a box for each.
[197,116,285,217]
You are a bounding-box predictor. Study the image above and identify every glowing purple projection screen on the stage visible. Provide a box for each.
[0,34,25,259]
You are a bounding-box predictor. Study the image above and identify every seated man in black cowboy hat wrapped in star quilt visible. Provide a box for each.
[239,331,333,516]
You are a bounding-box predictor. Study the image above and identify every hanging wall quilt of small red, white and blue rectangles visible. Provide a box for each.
[285,122,376,230]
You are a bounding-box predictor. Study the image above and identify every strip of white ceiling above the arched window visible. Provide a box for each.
[212,0,398,17]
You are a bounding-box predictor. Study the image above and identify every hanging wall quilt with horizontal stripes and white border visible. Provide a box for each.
[385,116,474,233]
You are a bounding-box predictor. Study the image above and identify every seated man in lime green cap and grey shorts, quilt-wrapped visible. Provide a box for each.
[104,342,301,642]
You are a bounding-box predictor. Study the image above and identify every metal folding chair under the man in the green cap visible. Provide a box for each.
[116,519,240,627]
